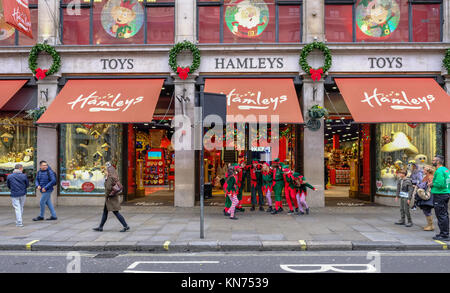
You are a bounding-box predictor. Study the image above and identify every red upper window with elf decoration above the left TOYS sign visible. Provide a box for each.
[61,0,175,45]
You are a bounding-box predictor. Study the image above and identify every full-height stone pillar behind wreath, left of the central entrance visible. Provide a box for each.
[173,0,198,207]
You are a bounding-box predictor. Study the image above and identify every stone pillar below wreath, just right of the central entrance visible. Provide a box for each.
[302,77,325,207]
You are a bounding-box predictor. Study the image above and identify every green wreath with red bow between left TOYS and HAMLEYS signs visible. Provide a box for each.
[169,41,200,79]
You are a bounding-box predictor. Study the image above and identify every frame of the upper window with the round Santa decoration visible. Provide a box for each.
[195,0,303,44]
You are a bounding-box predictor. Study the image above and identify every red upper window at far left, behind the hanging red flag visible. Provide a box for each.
[0,0,38,46]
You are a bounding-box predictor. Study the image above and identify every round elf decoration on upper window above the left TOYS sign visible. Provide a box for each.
[101,0,144,39]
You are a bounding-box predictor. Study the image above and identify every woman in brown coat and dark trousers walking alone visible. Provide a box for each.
[94,163,130,232]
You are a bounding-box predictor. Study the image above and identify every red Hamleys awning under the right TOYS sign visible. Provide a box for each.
[335,78,450,123]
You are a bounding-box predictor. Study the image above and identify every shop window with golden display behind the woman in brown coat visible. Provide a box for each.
[60,124,122,195]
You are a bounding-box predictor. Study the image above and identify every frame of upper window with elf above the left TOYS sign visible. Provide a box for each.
[59,0,176,46]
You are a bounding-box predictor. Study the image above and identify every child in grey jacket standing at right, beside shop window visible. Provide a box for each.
[395,169,413,227]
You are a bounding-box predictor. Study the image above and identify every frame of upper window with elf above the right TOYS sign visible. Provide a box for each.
[324,0,444,43]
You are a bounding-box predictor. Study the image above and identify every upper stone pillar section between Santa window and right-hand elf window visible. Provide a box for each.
[303,0,325,43]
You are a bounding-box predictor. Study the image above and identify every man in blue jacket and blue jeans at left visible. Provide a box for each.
[33,161,58,221]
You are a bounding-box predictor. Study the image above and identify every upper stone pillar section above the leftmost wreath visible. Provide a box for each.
[37,0,61,45]
